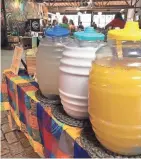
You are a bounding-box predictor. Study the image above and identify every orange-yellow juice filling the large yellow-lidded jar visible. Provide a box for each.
[88,57,141,155]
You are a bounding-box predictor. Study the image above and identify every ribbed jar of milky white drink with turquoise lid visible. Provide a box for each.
[59,27,104,119]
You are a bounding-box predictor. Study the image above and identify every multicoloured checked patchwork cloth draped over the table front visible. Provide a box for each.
[1,70,90,158]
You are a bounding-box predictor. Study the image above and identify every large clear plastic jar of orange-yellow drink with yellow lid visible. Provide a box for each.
[89,22,141,155]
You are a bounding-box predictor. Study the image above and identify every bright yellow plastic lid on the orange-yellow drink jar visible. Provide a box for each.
[108,21,141,41]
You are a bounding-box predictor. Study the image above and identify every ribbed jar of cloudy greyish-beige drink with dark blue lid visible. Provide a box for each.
[36,26,69,98]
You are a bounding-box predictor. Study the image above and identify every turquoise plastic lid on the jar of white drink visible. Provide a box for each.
[74,27,105,41]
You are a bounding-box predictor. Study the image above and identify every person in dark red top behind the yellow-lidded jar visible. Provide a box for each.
[105,12,125,29]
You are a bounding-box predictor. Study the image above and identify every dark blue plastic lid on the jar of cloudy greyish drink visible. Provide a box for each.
[45,25,70,37]
